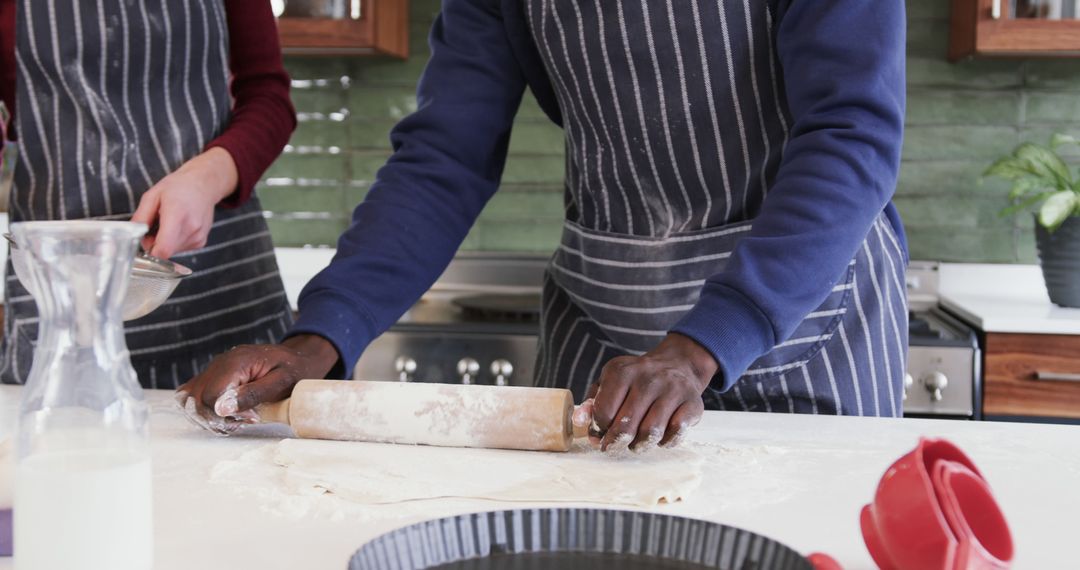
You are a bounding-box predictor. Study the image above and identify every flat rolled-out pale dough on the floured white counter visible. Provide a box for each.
[211,439,704,506]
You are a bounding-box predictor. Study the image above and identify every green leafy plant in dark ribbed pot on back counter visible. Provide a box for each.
[983,134,1080,308]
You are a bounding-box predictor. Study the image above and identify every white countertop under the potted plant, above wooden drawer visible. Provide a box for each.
[941,263,1080,335]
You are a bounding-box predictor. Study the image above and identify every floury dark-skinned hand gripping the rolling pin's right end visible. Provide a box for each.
[573,333,718,451]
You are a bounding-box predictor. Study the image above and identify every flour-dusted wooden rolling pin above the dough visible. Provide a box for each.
[256,380,587,451]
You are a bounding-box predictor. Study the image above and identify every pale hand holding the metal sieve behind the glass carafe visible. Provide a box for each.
[132,147,239,259]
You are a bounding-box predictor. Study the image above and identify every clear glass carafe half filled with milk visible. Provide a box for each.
[11,221,153,570]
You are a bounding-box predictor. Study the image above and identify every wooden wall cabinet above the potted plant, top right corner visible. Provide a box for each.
[948,0,1080,62]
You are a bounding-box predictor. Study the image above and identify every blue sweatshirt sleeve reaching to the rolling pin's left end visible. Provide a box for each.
[289,0,525,371]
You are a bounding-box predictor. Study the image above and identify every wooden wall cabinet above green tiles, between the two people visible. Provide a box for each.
[278,0,408,59]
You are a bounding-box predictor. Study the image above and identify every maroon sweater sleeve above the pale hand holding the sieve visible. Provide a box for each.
[207,0,296,206]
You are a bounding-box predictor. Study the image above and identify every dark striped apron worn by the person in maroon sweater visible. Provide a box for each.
[0,0,292,389]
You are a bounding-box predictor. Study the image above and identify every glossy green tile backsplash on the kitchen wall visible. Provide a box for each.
[258,0,1080,262]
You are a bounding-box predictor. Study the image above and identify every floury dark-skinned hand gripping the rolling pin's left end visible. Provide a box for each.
[176,335,338,435]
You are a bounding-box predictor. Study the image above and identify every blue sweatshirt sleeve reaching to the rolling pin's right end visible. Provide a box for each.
[673,0,905,390]
